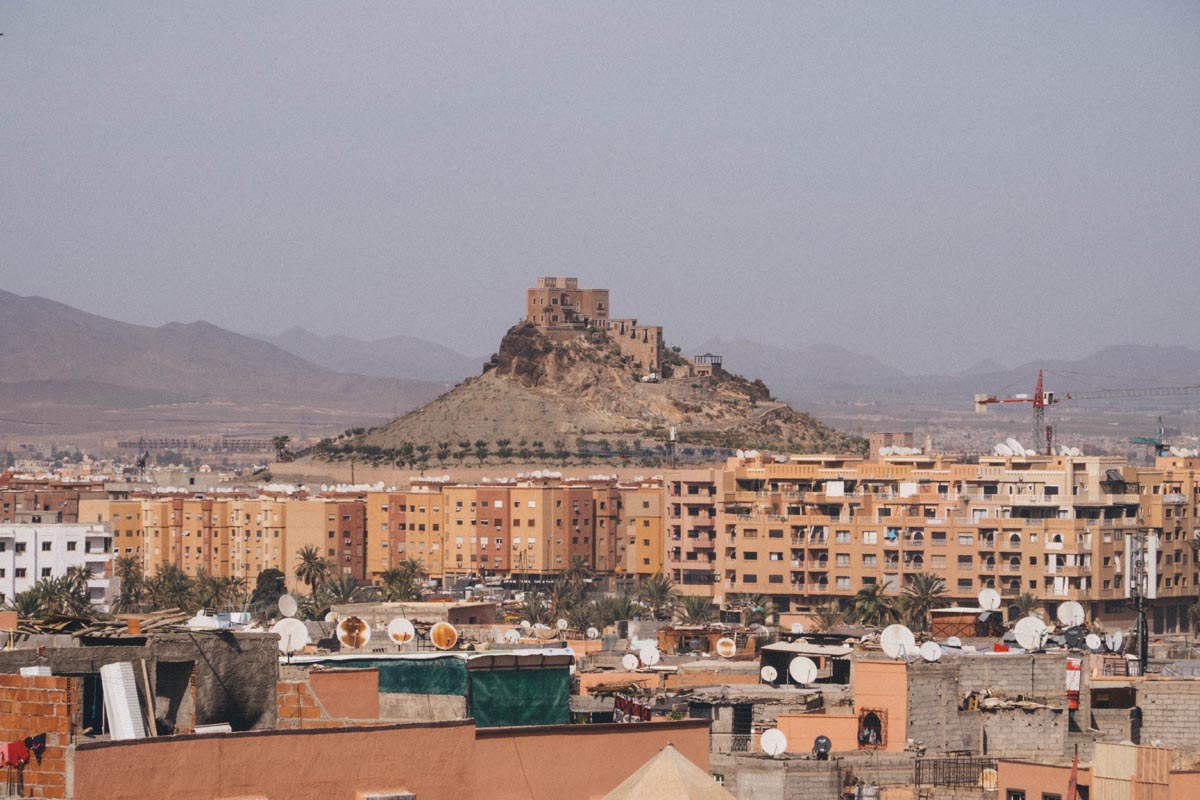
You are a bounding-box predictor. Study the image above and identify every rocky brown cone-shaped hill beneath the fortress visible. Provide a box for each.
[352,323,863,452]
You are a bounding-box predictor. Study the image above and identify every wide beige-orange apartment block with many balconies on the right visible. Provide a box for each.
[666,456,1200,632]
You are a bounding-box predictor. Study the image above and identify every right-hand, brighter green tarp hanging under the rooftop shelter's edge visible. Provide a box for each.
[470,667,571,728]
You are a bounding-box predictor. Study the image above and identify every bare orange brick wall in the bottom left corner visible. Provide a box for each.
[0,675,71,798]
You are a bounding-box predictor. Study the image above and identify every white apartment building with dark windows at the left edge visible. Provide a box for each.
[0,523,113,610]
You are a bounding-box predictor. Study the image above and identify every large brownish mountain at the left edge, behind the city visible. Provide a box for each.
[0,291,442,429]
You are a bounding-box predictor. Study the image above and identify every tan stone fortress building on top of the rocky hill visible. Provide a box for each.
[524,277,662,375]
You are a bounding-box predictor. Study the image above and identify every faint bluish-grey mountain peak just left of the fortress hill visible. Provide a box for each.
[257,327,486,383]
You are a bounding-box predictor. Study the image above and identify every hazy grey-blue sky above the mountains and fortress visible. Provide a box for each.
[0,0,1200,371]
